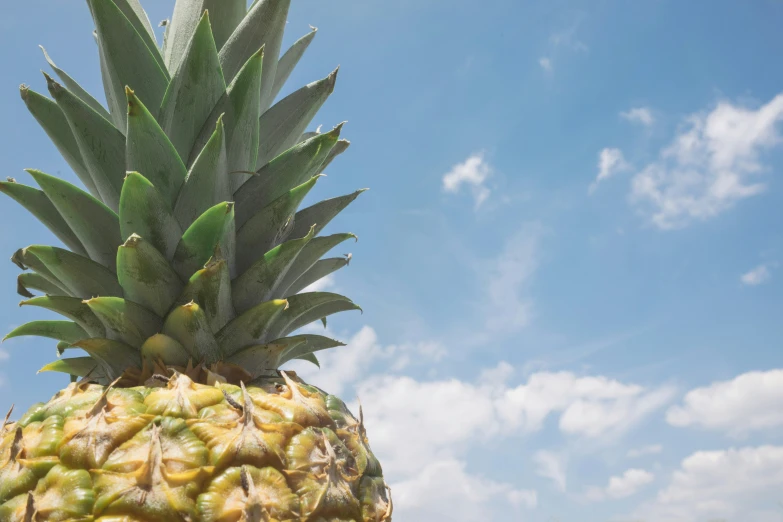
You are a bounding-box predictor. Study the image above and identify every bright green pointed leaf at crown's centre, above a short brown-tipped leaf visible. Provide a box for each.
[173,202,236,279]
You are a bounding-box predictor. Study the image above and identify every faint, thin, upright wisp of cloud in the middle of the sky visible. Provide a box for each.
[481,223,543,333]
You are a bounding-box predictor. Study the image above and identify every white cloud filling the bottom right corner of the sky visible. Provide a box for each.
[636,446,783,522]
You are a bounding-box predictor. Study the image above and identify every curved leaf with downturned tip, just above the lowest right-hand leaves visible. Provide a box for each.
[260,292,361,342]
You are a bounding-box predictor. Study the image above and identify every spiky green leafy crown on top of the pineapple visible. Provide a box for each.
[0,0,362,385]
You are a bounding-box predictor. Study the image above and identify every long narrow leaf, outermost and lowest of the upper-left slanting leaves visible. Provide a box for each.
[19,85,100,197]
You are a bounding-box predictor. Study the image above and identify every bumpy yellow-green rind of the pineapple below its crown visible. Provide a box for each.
[0,374,391,522]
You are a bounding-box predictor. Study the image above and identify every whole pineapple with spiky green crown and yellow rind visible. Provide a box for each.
[0,0,392,522]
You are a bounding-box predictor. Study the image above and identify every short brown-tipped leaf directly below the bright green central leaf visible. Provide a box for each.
[176,258,231,332]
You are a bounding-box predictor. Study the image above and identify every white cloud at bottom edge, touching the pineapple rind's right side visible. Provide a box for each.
[391,459,538,522]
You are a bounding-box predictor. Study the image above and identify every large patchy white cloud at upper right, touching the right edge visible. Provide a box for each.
[630,94,783,229]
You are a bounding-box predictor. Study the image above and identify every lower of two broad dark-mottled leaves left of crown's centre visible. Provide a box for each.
[117,234,184,317]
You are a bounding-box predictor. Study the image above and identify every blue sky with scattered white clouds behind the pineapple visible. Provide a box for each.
[0,0,783,522]
